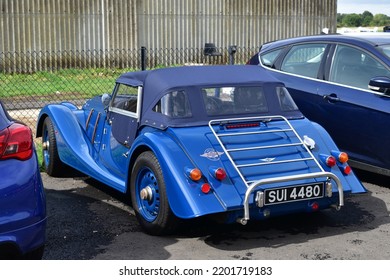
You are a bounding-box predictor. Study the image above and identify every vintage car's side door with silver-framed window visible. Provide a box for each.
[99,83,142,179]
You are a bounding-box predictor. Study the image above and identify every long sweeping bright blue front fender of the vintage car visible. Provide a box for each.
[37,104,125,191]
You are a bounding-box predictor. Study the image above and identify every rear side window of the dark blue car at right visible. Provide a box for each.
[280,44,326,78]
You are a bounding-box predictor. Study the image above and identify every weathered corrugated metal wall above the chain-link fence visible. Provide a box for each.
[0,0,337,52]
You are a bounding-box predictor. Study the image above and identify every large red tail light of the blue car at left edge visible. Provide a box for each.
[0,123,33,160]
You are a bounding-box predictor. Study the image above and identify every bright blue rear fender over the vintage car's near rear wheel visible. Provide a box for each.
[128,132,226,219]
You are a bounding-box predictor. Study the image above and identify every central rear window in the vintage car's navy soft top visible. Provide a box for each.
[202,86,268,116]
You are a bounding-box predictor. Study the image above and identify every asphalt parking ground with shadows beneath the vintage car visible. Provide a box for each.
[42,173,390,260]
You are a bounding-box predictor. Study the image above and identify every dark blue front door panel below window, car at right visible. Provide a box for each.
[317,81,390,168]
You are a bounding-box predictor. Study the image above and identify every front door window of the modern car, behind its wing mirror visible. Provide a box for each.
[329,45,390,89]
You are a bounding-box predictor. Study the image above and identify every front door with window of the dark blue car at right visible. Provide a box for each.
[313,44,390,169]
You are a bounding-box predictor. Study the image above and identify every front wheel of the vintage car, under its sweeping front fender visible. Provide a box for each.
[42,117,70,177]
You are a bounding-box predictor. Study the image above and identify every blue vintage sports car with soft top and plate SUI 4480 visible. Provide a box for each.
[37,65,365,235]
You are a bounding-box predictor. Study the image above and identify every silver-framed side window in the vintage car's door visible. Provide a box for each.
[111,84,138,113]
